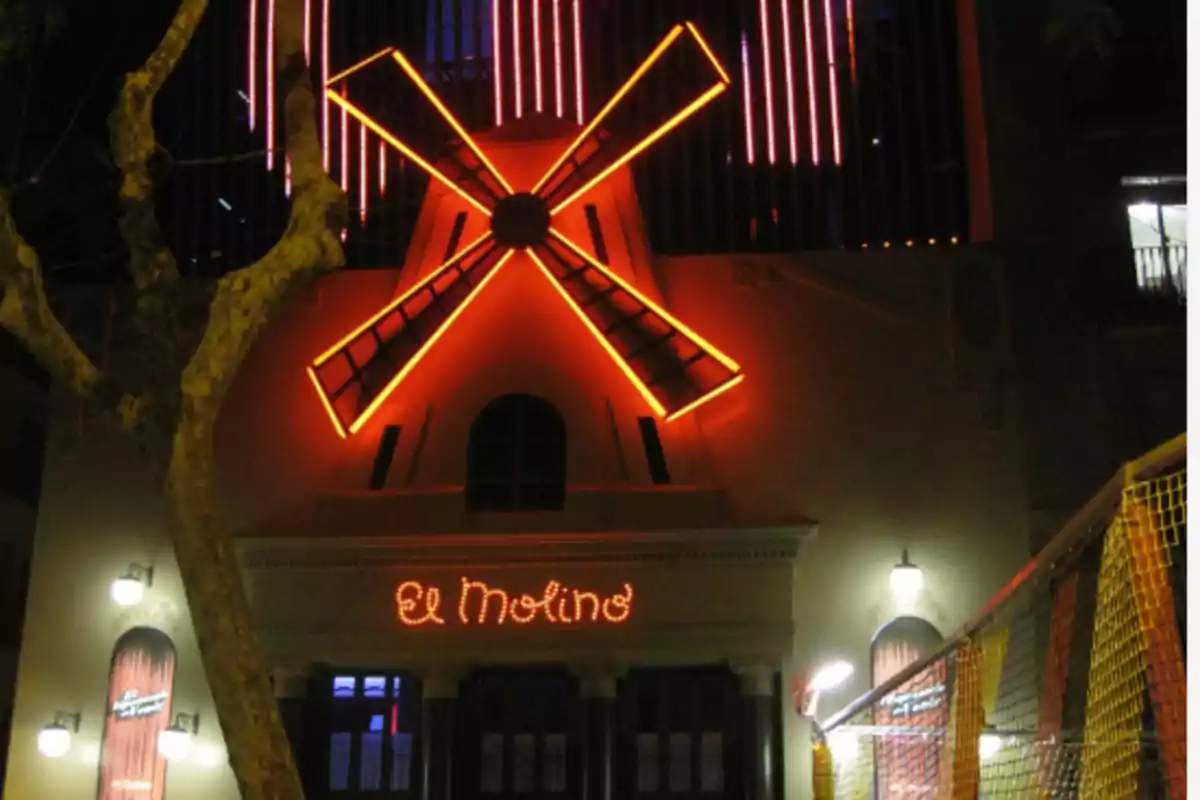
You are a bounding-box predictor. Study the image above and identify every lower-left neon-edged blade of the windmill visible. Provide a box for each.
[308,233,512,439]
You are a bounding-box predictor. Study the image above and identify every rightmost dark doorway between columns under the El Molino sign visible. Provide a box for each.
[614,667,744,800]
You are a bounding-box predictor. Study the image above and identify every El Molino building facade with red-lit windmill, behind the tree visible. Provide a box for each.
[5,0,1180,800]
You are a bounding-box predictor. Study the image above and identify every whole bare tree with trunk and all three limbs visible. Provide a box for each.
[7,0,347,800]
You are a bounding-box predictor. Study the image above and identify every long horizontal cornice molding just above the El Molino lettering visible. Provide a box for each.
[236,523,816,571]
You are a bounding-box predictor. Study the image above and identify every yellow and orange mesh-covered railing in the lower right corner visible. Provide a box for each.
[815,450,1187,800]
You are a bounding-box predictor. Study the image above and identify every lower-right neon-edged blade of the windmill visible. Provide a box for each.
[528,230,745,421]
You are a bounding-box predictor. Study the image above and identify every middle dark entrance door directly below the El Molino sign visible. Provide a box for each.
[455,668,583,800]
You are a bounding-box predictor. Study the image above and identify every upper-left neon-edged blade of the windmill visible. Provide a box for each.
[325,48,512,215]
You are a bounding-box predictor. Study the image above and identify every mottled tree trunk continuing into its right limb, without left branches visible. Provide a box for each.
[154,0,347,800]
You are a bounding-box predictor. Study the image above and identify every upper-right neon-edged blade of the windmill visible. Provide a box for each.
[533,23,730,216]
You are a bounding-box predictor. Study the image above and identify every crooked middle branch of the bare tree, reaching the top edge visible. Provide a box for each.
[108,0,209,291]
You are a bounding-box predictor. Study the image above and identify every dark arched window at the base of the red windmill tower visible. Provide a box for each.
[467,395,566,511]
